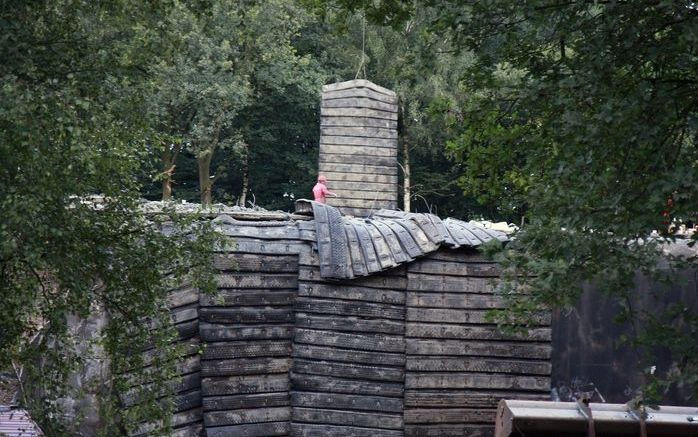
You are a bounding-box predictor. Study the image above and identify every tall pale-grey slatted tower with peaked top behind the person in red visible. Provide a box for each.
[318,79,397,217]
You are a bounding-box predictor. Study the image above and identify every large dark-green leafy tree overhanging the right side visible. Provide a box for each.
[318,0,698,400]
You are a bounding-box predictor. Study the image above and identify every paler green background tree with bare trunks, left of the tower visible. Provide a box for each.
[152,0,321,205]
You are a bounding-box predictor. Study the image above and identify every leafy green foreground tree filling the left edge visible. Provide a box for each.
[0,0,216,436]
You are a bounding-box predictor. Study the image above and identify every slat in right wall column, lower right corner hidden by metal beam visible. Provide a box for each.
[405,389,550,408]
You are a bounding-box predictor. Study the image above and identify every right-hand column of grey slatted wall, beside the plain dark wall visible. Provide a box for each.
[404,249,551,437]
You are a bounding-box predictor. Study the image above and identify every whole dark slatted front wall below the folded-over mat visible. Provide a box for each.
[125,221,551,437]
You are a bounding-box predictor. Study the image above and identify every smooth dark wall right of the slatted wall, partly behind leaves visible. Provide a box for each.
[551,260,698,405]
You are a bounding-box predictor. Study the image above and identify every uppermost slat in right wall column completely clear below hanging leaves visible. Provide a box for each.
[406,339,552,360]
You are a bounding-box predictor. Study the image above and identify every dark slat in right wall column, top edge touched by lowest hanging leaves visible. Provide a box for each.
[405,322,551,341]
